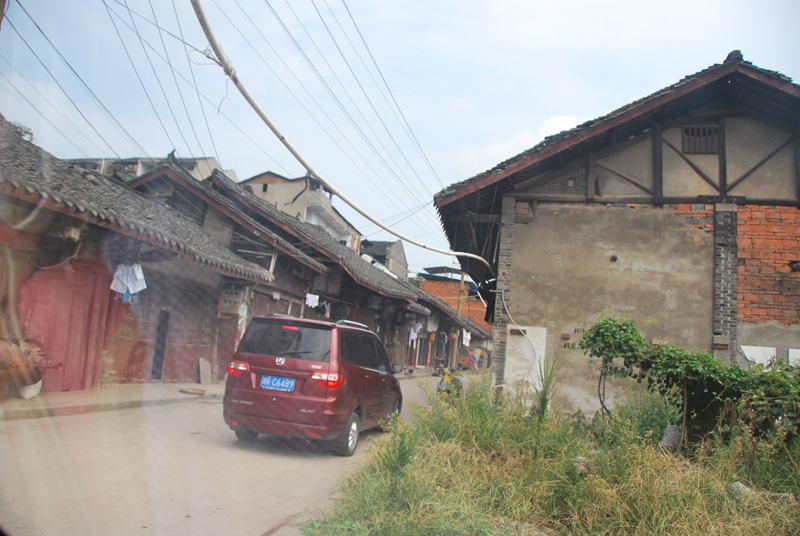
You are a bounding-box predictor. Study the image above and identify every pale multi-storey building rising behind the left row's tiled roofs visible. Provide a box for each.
[240,171,361,252]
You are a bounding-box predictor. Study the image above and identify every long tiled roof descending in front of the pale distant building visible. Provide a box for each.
[206,172,418,301]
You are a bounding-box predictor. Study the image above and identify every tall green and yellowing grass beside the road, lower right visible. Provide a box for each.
[303,376,800,536]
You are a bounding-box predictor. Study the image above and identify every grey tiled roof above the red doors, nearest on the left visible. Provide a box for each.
[0,115,272,281]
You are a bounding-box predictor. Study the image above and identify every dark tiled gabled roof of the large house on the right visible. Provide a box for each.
[435,50,800,207]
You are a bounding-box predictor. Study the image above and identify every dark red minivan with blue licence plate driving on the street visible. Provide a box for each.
[223,315,403,456]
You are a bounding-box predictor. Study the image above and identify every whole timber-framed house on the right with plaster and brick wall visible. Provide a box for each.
[435,51,800,411]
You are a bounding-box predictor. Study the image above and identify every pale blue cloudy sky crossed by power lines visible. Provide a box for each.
[0,0,800,271]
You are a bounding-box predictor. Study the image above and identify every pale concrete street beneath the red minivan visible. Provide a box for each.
[0,375,435,536]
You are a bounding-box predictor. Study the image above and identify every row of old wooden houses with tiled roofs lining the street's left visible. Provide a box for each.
[0,112,488,395]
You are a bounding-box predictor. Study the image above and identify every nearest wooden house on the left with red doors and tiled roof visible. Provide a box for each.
[0,117,278,391]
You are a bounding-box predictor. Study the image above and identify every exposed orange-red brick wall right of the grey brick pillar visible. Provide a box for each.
[738,205,800,326]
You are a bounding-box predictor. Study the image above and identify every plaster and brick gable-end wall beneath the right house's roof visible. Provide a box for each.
[495,116,800,411]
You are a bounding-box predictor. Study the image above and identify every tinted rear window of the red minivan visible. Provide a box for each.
[240,320,331,361]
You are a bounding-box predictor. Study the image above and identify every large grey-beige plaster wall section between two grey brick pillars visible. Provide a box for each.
[506,203,713,412]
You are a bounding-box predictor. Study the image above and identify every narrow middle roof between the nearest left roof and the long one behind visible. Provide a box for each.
[131,164,327,273]
